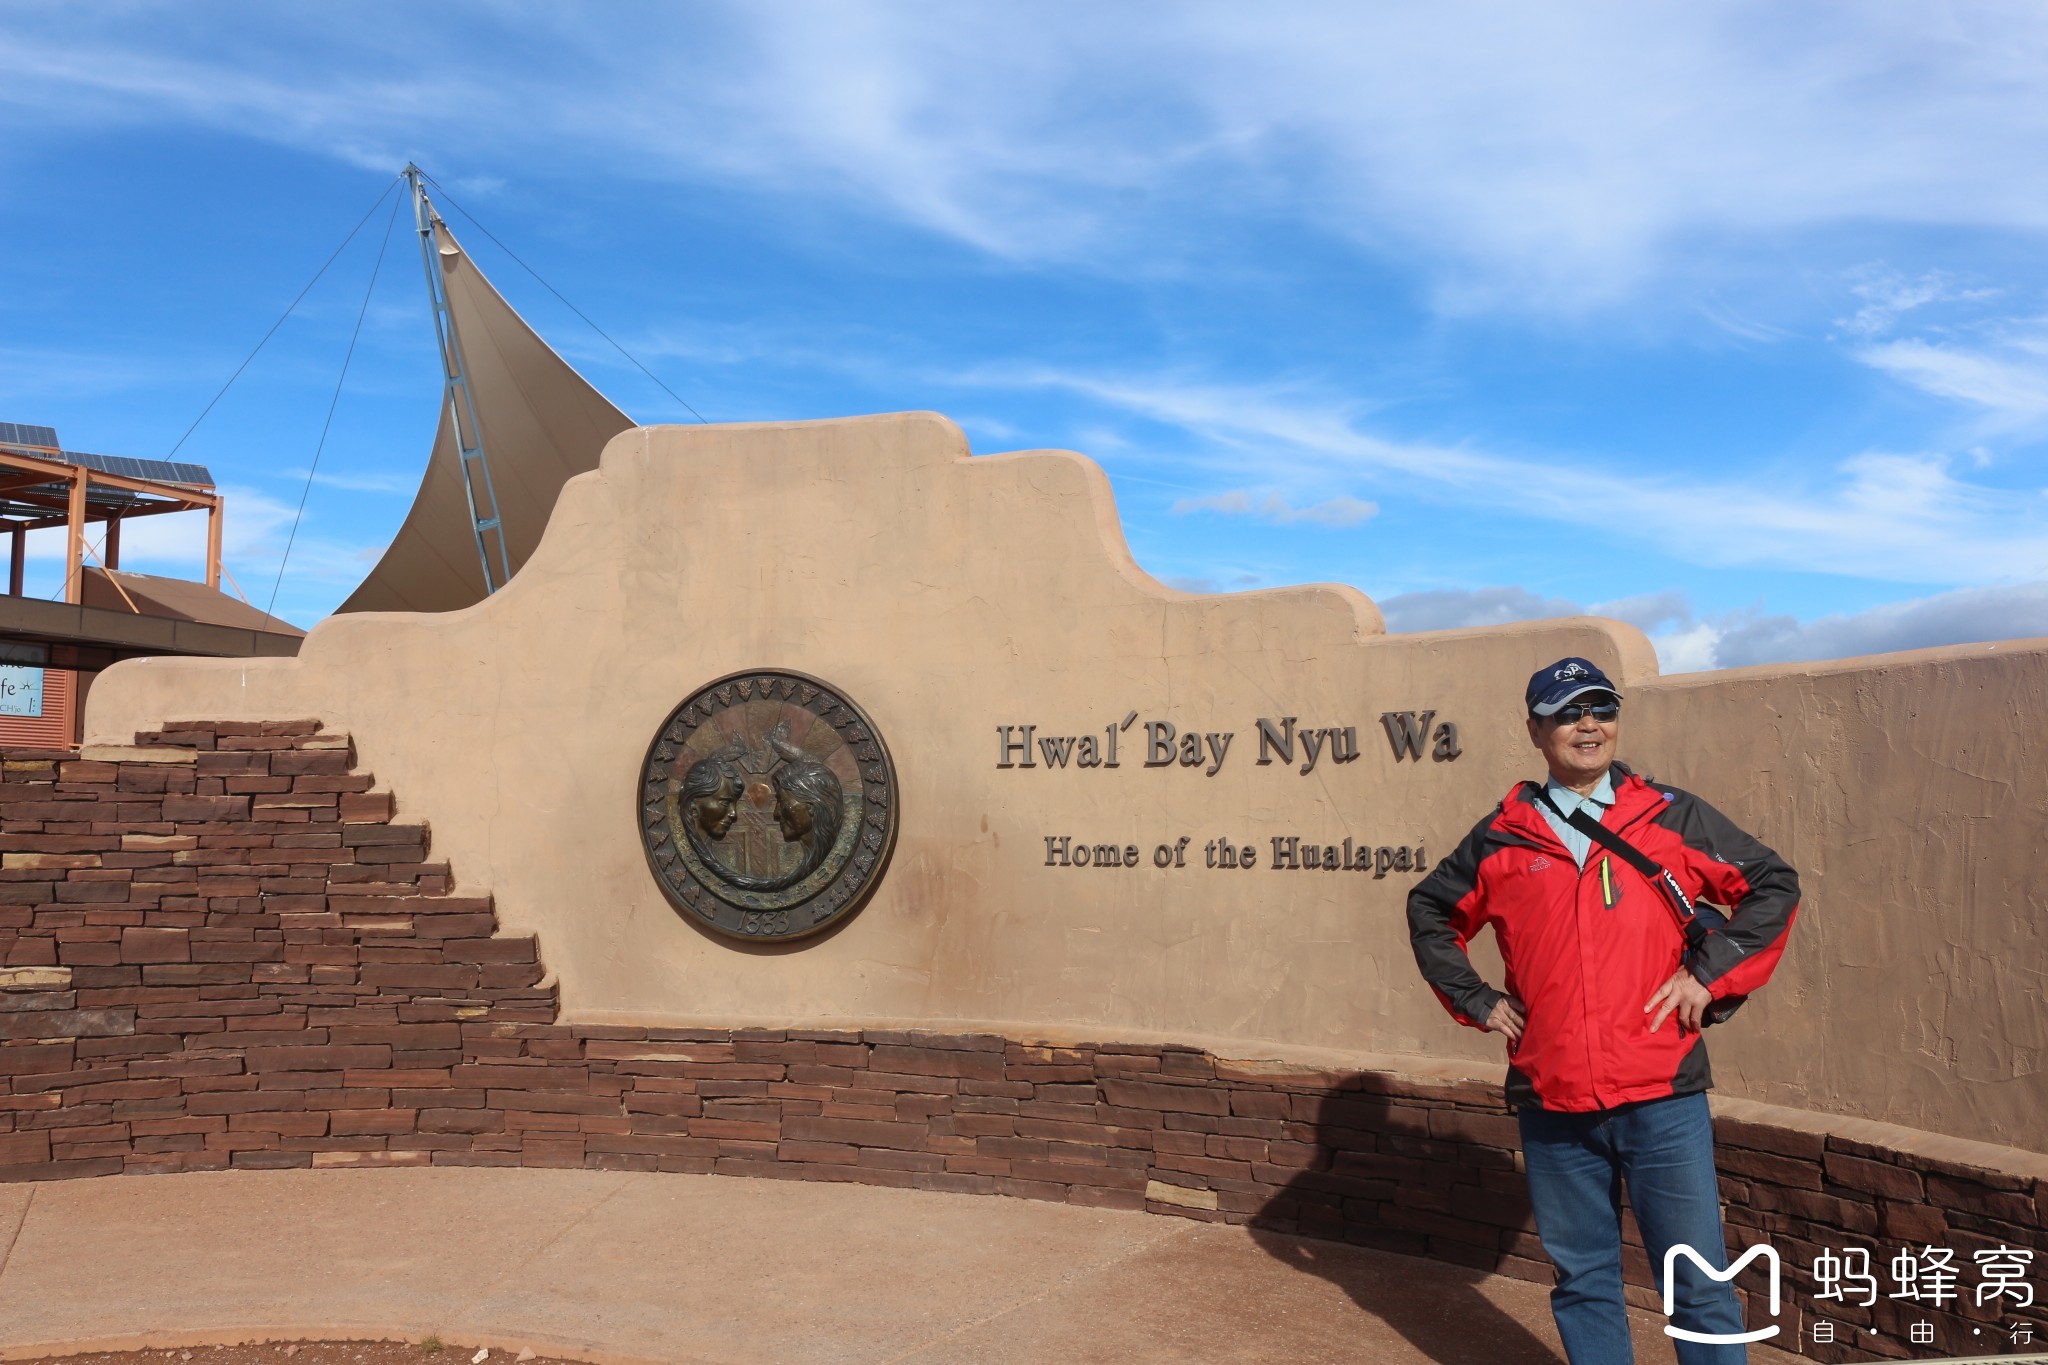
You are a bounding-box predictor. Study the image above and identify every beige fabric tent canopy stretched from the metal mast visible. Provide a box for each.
[336,221,633,612]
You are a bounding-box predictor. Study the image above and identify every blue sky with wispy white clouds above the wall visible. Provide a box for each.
[0,0,2048,671]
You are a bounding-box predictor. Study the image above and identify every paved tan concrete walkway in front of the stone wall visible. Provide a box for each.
[0,1169,1792,1365]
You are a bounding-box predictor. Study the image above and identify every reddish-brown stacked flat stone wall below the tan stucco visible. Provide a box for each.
[0,720,2048,1359]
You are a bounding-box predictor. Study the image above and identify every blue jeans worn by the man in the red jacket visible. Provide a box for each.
[1520,1095,1749,1365]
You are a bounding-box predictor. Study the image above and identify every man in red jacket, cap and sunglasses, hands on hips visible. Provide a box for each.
[1409,659,1798,1365]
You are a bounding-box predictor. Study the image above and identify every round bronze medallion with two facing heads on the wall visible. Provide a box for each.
[639,671,897,941]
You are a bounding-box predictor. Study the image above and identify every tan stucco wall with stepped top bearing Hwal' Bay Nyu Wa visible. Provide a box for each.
[86,413,2048,1148]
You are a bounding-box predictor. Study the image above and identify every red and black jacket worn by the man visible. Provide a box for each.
[1407,763,1798,1111]
